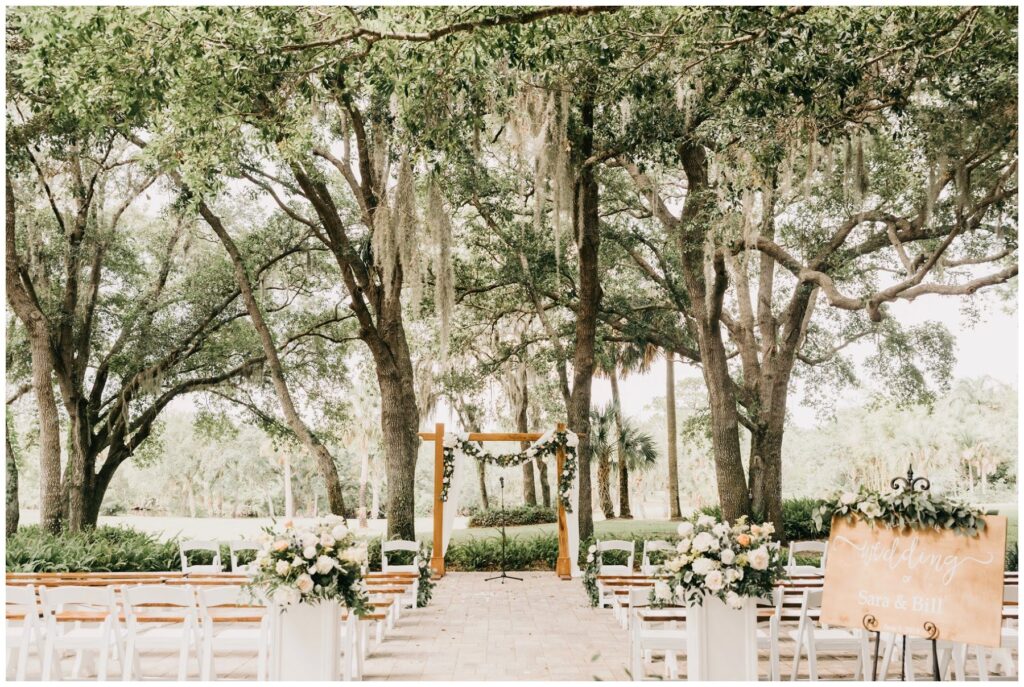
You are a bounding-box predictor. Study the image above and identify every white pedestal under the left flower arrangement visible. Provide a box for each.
[270,601,341,681]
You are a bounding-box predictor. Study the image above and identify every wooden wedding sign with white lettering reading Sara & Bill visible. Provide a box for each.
[821,515,1007,647]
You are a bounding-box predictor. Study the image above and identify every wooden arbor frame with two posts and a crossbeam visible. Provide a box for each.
[420,422,572,579]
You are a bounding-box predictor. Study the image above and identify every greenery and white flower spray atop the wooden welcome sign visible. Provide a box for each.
[813,486,985,536]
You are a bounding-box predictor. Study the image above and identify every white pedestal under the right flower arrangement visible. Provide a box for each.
[686,597,758,682]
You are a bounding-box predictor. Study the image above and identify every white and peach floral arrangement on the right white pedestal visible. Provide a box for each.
[650,515,784,608]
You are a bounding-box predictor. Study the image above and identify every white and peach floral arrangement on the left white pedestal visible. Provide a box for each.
[249,516,367,614]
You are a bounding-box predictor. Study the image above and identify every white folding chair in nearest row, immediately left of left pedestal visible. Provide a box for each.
[198,586,270,681]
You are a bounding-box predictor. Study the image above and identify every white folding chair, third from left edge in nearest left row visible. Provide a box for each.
[122,585,201,681]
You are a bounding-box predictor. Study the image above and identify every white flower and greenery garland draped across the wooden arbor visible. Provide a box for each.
[441,430,580,513]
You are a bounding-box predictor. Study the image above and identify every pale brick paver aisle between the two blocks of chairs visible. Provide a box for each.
[366,572,629,680]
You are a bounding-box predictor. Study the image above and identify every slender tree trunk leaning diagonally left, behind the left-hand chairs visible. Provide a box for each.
[199,201,348,516]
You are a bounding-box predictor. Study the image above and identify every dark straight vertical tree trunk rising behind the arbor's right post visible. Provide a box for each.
[568,95,601,541]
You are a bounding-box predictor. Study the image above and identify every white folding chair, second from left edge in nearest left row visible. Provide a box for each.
[39,586,124,682]
